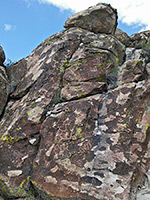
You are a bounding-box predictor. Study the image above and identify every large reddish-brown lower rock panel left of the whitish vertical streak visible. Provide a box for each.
[31,95,101,199]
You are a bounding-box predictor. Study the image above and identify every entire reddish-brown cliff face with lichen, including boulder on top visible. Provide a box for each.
[0,4,150,200]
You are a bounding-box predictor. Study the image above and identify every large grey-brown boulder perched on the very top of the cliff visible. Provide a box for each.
[64,3,117,34]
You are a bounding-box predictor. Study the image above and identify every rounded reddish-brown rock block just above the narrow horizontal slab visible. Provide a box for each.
[63,50,116,84]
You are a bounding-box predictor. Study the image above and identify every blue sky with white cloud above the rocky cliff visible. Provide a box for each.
[0,0,148,62]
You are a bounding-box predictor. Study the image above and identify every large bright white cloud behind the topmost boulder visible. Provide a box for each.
[25,0,150,29]
